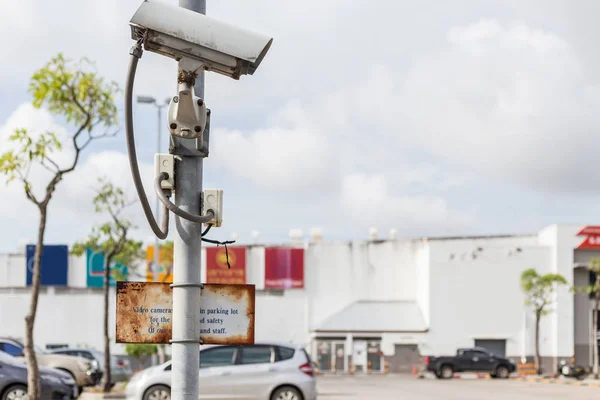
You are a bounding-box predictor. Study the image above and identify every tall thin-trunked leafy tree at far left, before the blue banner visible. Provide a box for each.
[0,54,119,400]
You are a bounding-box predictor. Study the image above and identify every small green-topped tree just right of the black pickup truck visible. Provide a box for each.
[521,268,567,374]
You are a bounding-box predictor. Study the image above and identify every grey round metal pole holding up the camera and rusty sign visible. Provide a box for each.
[171,0,206,400]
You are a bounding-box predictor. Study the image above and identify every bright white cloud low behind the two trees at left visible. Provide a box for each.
[0,104,153,250]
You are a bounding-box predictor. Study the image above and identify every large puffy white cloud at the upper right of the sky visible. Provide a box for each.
[388,21,600,191]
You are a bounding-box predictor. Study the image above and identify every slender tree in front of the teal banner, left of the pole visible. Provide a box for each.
[72,178,144,392]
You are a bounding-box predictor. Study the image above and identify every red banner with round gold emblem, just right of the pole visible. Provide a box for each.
[206,247,246,285]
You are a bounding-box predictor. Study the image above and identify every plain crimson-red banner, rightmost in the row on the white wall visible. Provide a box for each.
[265,247,304,289]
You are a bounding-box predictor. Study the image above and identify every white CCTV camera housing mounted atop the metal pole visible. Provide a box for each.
[129,1,273,79]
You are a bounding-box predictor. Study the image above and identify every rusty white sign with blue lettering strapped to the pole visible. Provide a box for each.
[116,282,255,344]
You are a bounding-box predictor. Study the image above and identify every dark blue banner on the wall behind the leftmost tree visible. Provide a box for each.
[25,244,69,286]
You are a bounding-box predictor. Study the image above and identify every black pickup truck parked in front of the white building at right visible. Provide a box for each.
[425,347,517,379]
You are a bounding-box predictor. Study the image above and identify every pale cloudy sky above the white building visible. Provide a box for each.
[0,0,600,251]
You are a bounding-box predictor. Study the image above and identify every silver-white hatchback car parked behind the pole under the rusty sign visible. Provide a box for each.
[126,343,317,400]
